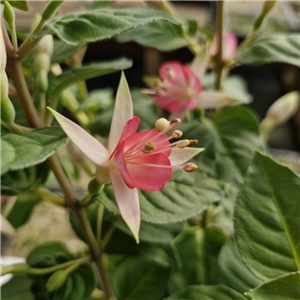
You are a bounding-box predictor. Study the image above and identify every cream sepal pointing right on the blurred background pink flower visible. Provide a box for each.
[198,91,238,109]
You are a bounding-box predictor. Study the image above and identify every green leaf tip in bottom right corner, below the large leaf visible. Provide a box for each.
[245,272,300,300]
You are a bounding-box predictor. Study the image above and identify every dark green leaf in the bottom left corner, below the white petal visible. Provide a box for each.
[0,275,34,300]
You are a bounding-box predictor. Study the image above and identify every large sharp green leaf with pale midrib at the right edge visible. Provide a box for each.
[234,153,300,280]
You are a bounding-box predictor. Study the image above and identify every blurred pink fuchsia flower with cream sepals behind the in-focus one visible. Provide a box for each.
[143,49,237,114]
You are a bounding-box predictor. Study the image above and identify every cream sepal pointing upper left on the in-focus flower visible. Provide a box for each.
[48,107,109,167]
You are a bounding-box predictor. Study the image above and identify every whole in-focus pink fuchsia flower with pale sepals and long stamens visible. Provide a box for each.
[50,75,203,242]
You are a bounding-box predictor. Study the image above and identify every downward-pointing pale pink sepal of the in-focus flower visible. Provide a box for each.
[109,171,141,243]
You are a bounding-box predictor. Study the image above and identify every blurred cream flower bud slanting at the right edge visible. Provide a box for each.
[260,91,300,134]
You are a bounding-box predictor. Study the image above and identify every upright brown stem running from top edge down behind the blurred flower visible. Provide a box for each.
[215,0,224,90]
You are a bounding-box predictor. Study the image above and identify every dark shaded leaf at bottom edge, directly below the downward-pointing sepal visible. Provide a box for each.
[111,257,170,300]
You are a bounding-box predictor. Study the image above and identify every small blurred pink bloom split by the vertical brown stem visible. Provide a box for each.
[210,33,238,61]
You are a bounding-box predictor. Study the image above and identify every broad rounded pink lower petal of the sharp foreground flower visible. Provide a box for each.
[127,153,172,191]
